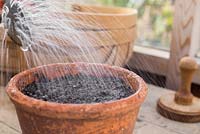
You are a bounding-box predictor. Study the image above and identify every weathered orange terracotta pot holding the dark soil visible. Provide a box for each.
[7,63,147,134]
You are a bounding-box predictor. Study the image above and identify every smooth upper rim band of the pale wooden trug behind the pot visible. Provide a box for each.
[52,4,138,30]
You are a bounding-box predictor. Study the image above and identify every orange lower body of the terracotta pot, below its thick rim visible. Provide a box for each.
[17,109,138,134]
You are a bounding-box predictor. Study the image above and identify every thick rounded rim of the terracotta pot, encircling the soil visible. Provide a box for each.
[6,62,147,119]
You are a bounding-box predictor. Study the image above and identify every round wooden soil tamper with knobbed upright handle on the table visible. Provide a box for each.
[157,57,200,123]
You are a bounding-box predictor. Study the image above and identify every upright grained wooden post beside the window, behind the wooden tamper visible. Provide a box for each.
[166,0,197,90]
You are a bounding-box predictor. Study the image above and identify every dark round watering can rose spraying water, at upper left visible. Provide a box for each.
[2,0,31,48]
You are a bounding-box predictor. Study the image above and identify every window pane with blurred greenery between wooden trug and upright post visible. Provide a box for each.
[97,0,175,50]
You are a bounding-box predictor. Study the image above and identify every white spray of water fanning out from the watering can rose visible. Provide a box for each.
[1,0,139,102]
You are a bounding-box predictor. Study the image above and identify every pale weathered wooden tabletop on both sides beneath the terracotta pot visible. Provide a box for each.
[0,85,200,134]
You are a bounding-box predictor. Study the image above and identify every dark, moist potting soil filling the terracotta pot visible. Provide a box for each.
[22,74,135,104]
